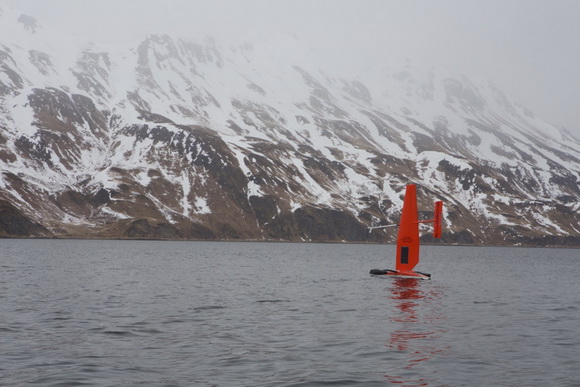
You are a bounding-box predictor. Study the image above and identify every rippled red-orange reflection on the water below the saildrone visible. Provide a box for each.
[385,278,447,386]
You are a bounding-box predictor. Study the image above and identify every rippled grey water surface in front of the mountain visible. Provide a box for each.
[0,239,580,386]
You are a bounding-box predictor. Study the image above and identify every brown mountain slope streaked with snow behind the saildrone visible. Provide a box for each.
[0,9,580,246]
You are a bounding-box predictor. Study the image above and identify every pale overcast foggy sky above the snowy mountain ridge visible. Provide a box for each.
[0,0,580,134]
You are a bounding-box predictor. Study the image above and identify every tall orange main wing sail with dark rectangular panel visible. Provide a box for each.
[395,184,419,271]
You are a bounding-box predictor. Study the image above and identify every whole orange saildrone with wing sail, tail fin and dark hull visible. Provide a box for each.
[369,184,443,279]
